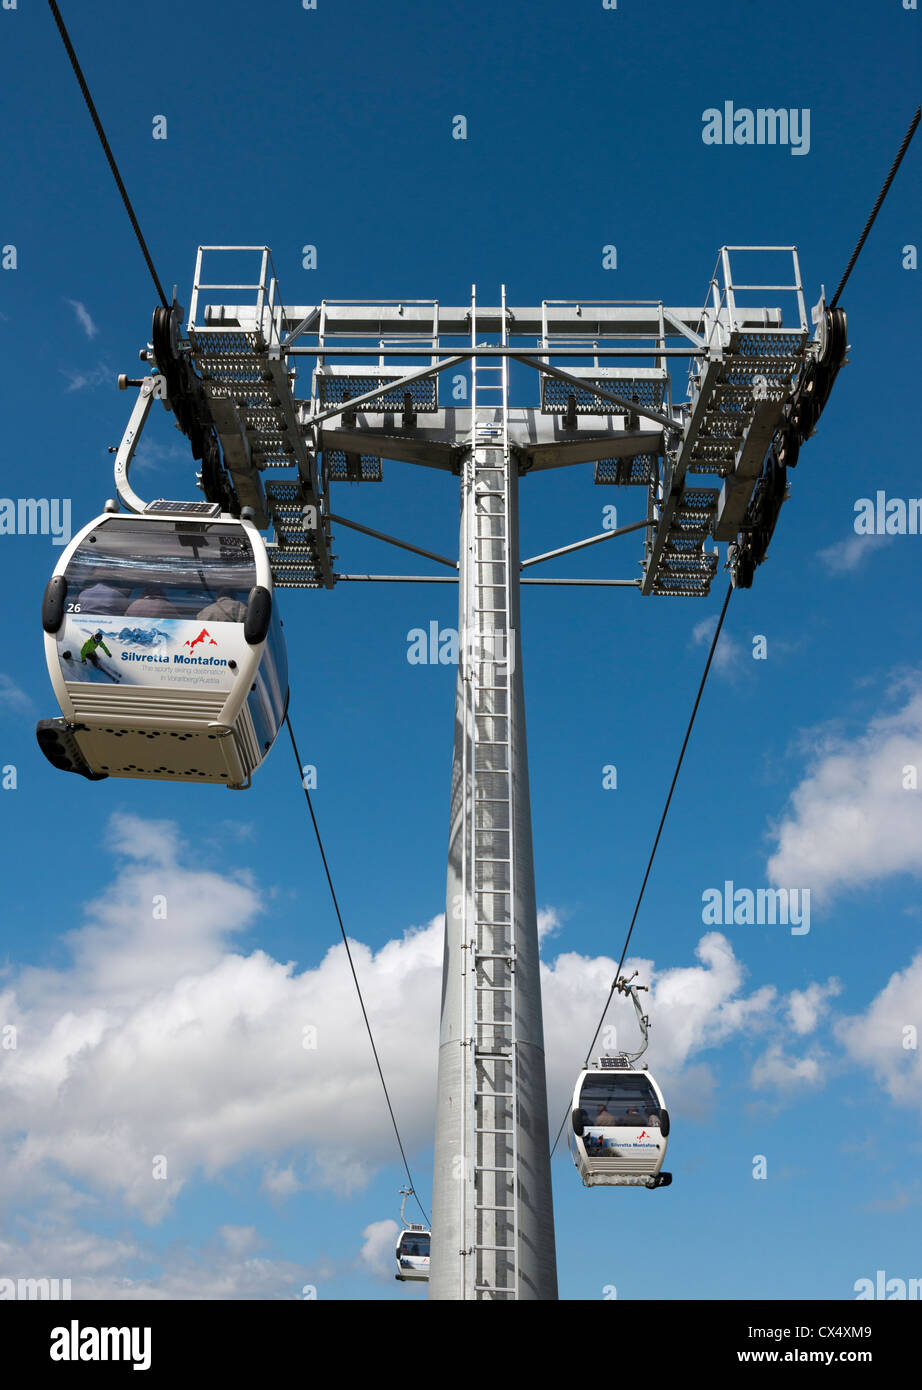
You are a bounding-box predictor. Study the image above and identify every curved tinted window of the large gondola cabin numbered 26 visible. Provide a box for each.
[65,517,256,623]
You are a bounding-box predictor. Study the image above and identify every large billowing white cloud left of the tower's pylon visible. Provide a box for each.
[0,816,442,1220]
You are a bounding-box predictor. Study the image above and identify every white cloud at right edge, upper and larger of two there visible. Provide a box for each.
[768,680,922,897]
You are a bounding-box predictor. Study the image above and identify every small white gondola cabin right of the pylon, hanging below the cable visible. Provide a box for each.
[570,1056,672,1187]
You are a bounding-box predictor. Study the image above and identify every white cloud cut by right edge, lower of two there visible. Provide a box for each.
[834,952,922,1113]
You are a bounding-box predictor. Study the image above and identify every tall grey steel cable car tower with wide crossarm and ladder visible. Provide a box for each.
[61,246,846,1301]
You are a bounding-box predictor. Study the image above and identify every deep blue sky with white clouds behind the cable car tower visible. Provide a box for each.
[0,0,922,1300]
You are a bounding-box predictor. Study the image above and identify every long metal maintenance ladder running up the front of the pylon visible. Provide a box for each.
[462,285,519,1300]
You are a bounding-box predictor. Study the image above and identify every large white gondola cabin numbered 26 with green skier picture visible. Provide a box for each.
[36,502,288,788]
